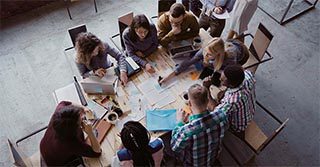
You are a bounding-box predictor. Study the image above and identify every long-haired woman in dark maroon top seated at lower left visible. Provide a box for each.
[40,101,101,166]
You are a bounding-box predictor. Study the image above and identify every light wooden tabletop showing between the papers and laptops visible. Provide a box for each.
[84,30,211,166]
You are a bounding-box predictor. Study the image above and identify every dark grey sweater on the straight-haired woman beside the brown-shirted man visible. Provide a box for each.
[122,24,158,67]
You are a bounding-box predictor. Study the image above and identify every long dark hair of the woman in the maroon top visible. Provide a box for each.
[52,105,83,141]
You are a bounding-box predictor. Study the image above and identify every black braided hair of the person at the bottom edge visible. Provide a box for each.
[120,121,154,166]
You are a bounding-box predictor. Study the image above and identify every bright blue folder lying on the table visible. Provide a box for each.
[146,109,177,131]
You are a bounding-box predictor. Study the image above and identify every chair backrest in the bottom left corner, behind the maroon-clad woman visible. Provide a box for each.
[8,139,32,167]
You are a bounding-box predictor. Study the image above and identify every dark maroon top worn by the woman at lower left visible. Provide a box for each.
[40,101,101,166]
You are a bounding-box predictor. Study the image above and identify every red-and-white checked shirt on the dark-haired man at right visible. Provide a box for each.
[215,70,256,132]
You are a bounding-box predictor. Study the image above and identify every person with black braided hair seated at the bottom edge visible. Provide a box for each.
[111,121,164,167]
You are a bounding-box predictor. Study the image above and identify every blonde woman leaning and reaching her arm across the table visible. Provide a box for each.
[159,38,249,84]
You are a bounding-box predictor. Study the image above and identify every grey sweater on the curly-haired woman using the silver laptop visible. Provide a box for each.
[76,43,127,78]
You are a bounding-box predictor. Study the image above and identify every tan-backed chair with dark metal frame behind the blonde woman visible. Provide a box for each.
[244,23,273,73]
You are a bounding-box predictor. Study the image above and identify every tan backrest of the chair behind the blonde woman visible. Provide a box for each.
[249,23,273,60]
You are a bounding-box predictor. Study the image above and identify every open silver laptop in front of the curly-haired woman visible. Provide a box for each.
[80,76,118,95]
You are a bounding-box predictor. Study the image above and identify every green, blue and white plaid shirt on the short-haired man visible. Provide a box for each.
[171,110,228,166]
